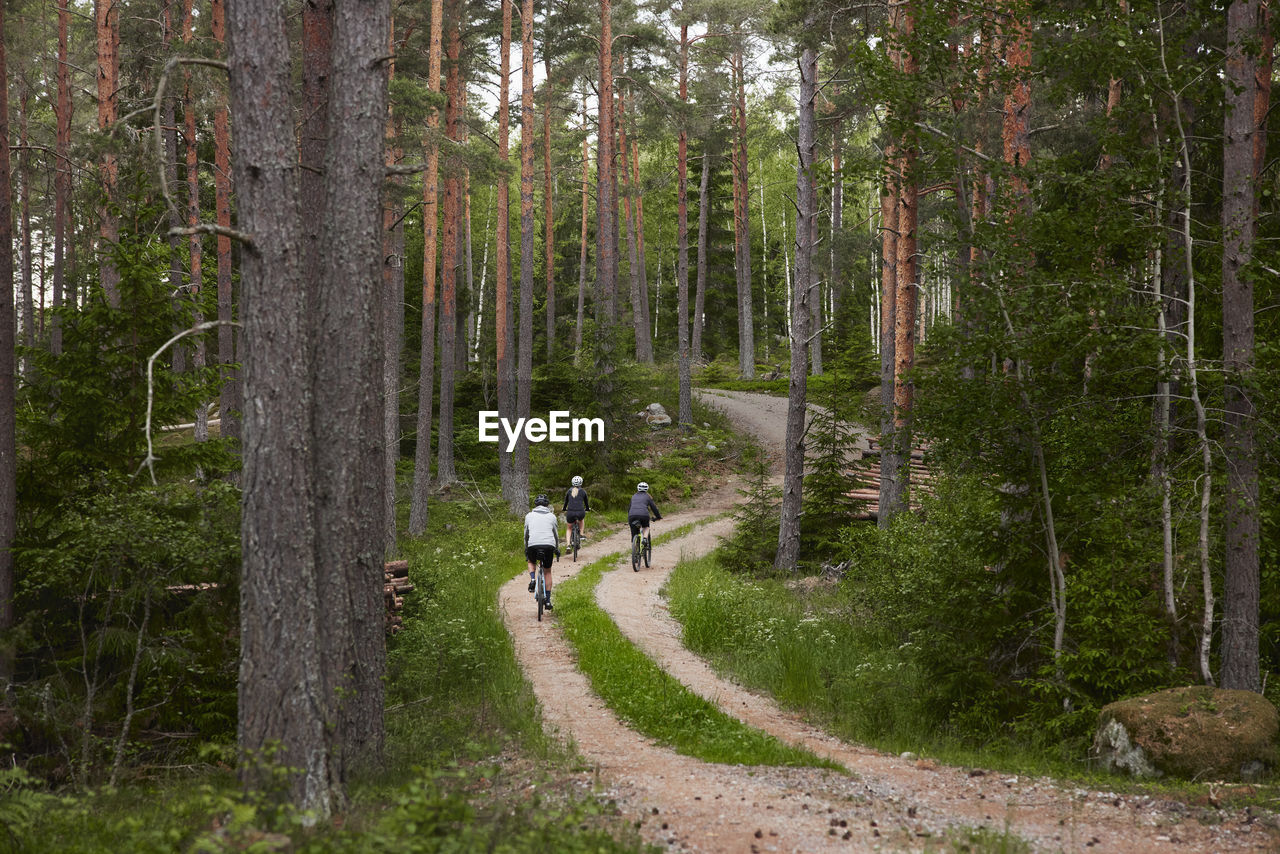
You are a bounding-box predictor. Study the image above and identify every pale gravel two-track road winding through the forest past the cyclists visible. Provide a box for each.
[499,392,1280,854]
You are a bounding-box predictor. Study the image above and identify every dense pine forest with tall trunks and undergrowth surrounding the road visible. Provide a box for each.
[0,0,1280,829]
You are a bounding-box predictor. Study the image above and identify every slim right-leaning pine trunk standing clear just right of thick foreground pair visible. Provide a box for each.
[408,0,444,536]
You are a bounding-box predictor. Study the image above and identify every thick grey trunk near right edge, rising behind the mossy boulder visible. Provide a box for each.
[1222,0,1270,691]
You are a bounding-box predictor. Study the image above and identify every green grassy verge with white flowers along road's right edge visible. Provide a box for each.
[663,554,1280,810]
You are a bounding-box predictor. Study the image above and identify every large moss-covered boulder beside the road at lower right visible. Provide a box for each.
[1091,685,1280,780]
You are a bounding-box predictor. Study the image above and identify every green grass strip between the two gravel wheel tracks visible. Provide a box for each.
[556,526,840,769]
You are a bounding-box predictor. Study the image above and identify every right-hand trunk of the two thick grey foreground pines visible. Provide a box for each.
[311,1,386,782]
